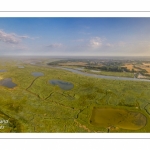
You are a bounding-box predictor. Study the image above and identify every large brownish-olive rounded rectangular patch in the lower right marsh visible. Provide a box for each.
[90,107,147,130]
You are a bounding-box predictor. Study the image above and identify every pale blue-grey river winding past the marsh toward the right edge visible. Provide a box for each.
[55,67,150,82]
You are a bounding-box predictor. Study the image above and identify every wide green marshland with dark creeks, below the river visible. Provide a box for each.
[0,61,150,133]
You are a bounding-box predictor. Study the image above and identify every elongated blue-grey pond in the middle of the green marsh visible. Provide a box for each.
[49,80,74,90]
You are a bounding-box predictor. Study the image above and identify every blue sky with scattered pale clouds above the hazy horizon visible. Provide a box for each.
[0,17,150,56]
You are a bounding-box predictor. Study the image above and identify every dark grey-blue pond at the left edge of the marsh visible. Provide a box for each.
[0,78,17,88]
